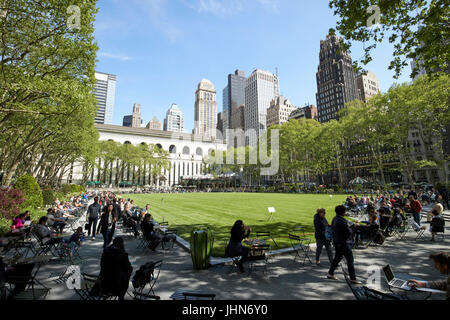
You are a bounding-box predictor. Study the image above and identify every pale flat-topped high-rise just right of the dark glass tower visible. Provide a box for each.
[244,69,280,146]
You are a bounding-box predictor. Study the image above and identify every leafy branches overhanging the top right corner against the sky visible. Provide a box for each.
[329,0,450,78]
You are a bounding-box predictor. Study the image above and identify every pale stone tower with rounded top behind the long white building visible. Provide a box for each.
[194,79,217,139]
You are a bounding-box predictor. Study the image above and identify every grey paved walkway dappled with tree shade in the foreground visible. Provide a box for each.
[38,208,450,300]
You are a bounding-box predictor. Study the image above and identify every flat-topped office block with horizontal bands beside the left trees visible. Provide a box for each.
[94,72,117,124]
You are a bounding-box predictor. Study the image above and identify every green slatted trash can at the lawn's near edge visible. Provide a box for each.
[191,229,214,270]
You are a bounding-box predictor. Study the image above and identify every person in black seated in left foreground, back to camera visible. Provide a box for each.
[99,237,133,300]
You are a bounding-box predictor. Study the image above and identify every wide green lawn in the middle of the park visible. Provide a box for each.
[123,193,346,257]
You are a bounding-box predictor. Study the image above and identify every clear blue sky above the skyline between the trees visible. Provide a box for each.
[95,0,410,132]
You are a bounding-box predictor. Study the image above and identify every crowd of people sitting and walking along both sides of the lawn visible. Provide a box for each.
[1,186,449,299]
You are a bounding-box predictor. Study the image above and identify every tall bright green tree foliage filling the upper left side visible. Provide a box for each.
[0,0,97,186]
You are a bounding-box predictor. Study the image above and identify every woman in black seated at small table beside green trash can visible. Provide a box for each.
[225,220,252,272]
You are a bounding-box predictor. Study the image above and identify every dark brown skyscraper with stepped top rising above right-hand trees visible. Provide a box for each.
[316,35,360,122]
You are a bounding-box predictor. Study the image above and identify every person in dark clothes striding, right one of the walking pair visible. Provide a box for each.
[327,206,360,284]
